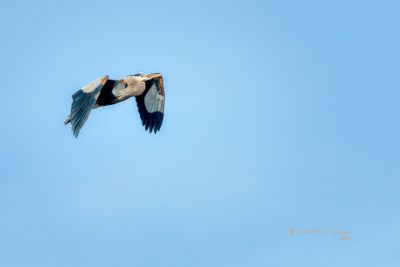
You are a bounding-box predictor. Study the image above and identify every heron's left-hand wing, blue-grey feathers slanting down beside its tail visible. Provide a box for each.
[69,76,108,137]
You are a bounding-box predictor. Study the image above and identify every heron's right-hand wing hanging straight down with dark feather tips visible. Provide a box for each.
[136,76,165,133]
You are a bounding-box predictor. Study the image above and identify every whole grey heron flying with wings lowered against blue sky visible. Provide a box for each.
[64,73,165,137]
